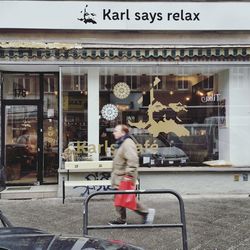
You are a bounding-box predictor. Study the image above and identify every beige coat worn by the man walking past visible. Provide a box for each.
[111,138,139,188]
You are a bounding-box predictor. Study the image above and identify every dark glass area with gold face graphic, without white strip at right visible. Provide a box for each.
[99,69,222,166]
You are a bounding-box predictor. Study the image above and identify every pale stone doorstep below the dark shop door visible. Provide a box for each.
[0,185,58,200]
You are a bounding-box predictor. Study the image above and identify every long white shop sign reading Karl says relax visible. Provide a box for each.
[0,1,250,30]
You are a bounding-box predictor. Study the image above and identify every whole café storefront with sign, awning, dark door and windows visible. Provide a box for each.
[0,1,250,193]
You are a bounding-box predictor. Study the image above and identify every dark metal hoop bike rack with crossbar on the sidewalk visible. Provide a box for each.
[83,189,188,250]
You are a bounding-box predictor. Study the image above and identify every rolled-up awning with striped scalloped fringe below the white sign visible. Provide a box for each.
[0,43,250,62]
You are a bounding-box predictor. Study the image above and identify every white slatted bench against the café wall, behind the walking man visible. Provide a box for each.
[62,161,140,204]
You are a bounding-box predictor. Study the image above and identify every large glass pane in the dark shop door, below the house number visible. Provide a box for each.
[4,105,41,184]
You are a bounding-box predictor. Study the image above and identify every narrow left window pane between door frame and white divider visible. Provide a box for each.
[62,68,88,161]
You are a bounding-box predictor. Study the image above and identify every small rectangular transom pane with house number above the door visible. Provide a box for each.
[3,74,40,100]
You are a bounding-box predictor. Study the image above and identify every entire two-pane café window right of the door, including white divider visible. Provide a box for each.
[62,65,250,167]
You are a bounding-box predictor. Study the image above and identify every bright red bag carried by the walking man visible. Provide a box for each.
[114,180,136,210]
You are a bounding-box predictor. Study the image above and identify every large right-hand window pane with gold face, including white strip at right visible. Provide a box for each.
[99,65,250,166]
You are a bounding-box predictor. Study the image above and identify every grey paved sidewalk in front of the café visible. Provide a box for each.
[0,195,250,250]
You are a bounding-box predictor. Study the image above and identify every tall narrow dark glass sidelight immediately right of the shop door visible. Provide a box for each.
[43,74,59,183]
